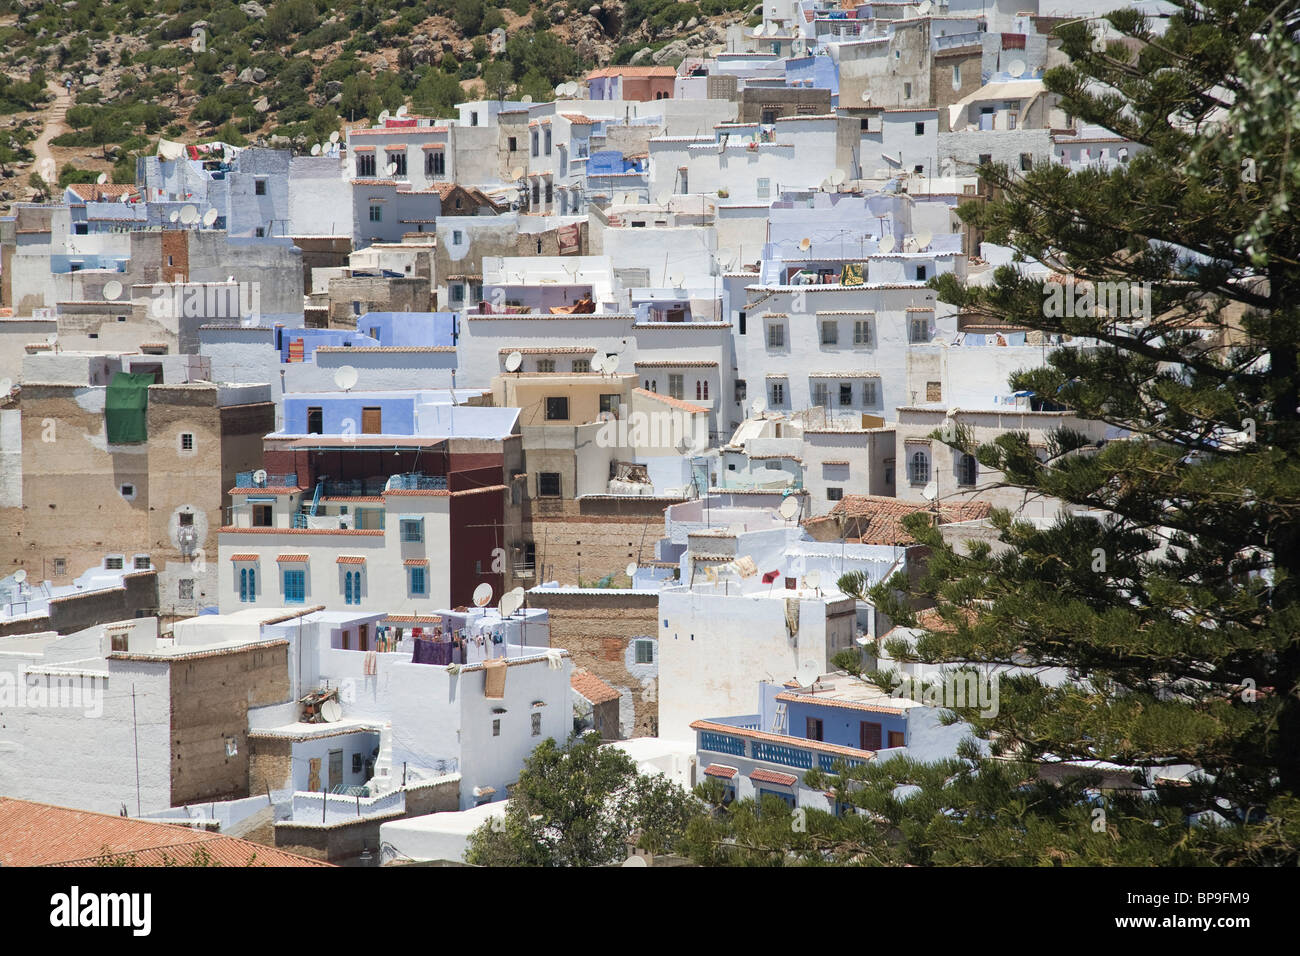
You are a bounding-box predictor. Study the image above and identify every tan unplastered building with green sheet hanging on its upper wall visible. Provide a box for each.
[9,352,276,614]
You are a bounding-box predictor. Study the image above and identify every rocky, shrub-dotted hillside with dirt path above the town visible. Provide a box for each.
[0,0,758,209]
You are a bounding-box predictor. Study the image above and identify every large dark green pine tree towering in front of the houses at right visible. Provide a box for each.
[692,0,1300,865]
